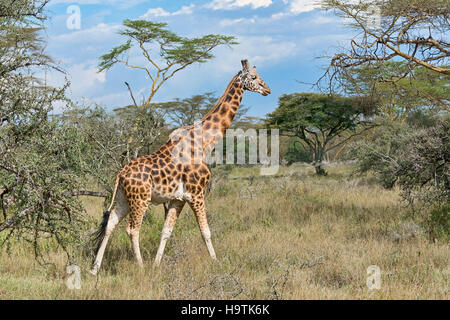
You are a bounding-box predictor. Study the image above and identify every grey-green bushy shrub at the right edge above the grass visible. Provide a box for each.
[353,117,450,236]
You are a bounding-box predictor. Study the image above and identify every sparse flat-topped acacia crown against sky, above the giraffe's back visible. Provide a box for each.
[98,19,237,105]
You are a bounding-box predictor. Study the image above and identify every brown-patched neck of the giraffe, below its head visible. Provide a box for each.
[201,71,244,151]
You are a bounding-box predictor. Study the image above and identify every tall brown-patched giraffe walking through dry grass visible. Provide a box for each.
[91,60,270,275]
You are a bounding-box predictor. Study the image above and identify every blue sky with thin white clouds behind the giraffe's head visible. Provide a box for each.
[45,0,352,117]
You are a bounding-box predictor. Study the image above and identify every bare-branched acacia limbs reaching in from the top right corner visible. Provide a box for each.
[321,0,450,89]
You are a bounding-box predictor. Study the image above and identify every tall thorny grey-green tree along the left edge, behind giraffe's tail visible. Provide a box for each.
[0,0,89,262]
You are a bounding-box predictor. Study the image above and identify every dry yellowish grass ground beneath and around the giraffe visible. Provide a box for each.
[0,165,450,299]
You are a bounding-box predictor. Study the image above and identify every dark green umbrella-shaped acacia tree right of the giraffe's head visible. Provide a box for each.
[266,93,375,175]
